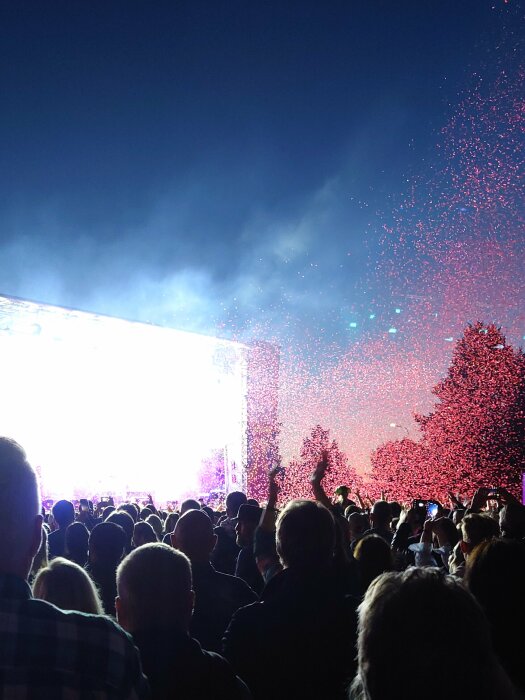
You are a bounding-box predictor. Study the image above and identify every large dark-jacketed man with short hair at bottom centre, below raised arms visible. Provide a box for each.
[223,500,356,700]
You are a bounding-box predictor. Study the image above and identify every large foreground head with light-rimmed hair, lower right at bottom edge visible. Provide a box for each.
[354,567,510,700]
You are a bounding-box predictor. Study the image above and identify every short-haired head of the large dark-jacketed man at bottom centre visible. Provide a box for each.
[275,500,335,570]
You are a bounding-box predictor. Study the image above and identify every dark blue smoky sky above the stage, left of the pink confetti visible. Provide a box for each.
[0,0,518,339]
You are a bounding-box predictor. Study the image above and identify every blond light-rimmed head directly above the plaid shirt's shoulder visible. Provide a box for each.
[33,557,104,615]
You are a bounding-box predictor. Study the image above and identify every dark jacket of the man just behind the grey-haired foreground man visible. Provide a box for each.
[190,563,257,652]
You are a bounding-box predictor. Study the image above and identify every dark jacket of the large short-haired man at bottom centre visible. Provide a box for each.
[223,569,357,700]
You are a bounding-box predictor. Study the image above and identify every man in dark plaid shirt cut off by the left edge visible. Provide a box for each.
[0,438,148,700]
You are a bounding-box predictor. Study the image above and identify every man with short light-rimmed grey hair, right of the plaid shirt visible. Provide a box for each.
[116,548,250,700]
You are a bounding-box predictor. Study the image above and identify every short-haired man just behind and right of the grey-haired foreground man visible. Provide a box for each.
[171,510,257,652]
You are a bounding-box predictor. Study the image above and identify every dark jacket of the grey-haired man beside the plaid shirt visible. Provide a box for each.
[133,630,251,700]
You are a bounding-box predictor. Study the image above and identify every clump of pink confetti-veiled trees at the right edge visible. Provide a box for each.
[372,322,525,499]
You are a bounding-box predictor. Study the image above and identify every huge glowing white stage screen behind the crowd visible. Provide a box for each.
[0,297,249,503]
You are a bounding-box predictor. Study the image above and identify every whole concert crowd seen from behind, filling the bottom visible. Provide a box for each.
[0,438,525,700]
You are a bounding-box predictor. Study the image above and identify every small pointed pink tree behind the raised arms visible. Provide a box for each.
[280,425,362,502]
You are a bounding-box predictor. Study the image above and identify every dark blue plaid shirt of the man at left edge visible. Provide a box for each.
[0,573,149,700]
